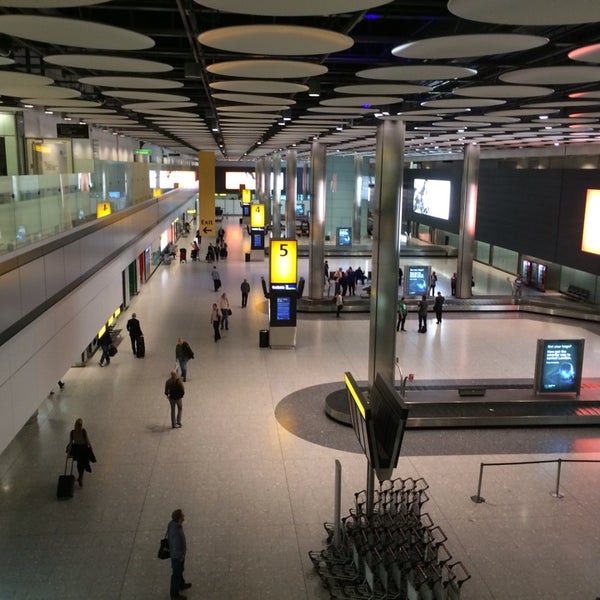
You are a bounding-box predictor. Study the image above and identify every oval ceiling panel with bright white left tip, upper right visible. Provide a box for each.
[392,33,549,59]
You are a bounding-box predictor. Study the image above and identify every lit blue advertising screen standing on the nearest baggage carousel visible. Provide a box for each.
[535,339,585,396]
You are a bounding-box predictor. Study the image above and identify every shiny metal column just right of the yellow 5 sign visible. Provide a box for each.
[308,142,326,300]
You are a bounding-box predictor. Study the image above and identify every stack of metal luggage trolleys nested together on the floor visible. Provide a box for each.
[309,478,471,600]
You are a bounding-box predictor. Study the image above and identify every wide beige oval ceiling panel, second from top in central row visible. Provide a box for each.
[198,25,354,56]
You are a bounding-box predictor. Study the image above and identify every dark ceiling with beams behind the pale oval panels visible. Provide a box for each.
[0,0,600,160]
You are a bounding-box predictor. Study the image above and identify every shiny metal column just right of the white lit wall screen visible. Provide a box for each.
[456,144,479,298]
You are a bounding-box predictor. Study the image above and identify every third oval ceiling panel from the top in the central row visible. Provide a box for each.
[206,60,328,79]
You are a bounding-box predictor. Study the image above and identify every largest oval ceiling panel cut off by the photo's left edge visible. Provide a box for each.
[0,15,154,50]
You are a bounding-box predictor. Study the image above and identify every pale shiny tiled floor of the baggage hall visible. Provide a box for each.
[0,220,600,600]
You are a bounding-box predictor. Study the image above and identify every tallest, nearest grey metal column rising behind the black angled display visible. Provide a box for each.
[369,120,405,387]
